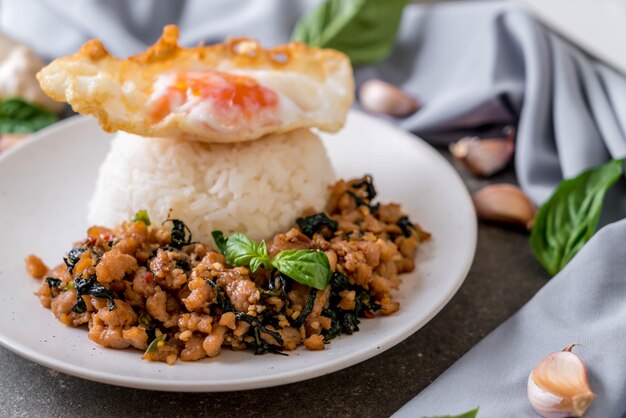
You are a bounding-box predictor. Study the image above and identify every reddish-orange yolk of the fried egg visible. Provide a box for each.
[150,70,278,122]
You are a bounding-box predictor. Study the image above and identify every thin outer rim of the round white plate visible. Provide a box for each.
[0,109,478,392]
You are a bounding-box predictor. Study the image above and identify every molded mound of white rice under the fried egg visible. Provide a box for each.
[87,130,335,243]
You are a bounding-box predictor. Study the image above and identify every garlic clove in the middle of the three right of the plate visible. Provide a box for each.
[450,129,515,177]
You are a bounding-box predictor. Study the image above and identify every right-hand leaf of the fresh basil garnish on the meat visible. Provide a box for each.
[272,250,332,290]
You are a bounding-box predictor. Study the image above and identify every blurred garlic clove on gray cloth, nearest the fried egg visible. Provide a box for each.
[359,80,420,116]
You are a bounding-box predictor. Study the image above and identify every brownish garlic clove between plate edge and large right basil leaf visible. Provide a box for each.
[473,184,536,228]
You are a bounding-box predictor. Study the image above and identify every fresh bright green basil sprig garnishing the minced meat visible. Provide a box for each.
[211,231,332,290]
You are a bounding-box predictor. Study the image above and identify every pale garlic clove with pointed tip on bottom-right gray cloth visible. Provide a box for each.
[528,344,596,418]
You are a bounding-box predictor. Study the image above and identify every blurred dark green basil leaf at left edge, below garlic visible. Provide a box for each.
[0,97,59,134]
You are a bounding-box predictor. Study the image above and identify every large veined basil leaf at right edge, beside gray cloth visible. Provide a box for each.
[530,159,624,276]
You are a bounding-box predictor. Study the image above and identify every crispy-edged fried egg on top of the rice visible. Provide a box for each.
[37,25,354,142]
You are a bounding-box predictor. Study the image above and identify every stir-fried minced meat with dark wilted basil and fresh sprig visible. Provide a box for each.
[26,176,429,364]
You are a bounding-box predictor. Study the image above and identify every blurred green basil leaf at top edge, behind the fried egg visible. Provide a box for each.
[292,0,408,64]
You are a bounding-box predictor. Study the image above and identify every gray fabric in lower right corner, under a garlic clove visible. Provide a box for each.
[394,220,626,418]
